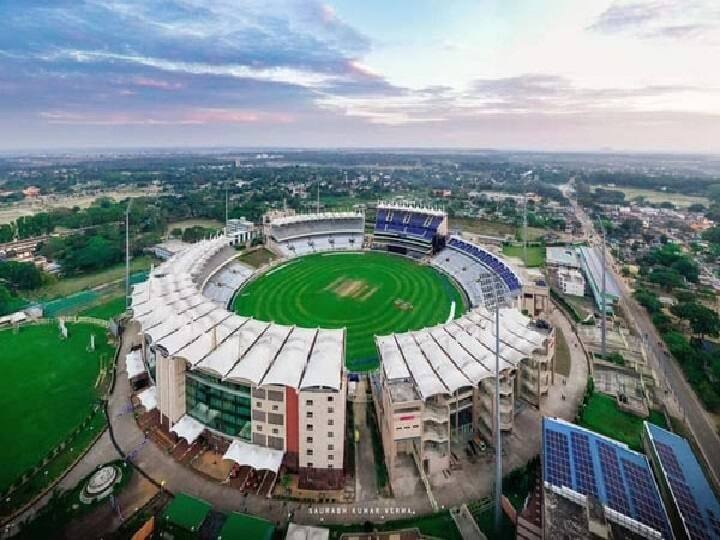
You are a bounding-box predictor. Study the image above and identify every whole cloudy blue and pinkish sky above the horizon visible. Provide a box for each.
[0,0,720,153]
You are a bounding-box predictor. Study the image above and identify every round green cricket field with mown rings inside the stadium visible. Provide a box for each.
[234,252,465,370]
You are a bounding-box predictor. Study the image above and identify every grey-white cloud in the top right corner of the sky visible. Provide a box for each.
[588,0,720,42]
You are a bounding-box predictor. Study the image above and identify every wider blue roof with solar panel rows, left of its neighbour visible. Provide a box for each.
[542,417,672,538]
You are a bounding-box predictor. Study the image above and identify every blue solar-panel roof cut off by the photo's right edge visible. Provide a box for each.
[645,422,720,540]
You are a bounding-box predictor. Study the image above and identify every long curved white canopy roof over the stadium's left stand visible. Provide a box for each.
[132,234,346,390]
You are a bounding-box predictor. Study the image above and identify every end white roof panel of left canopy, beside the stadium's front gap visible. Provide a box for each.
[300,330,345,390]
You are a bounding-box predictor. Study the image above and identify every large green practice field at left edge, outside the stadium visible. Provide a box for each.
[0,324,113,491]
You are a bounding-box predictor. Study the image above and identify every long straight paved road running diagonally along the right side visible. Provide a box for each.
[572,194,720,486]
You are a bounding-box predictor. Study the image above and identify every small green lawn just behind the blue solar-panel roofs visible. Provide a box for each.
[580,392,667,451]
